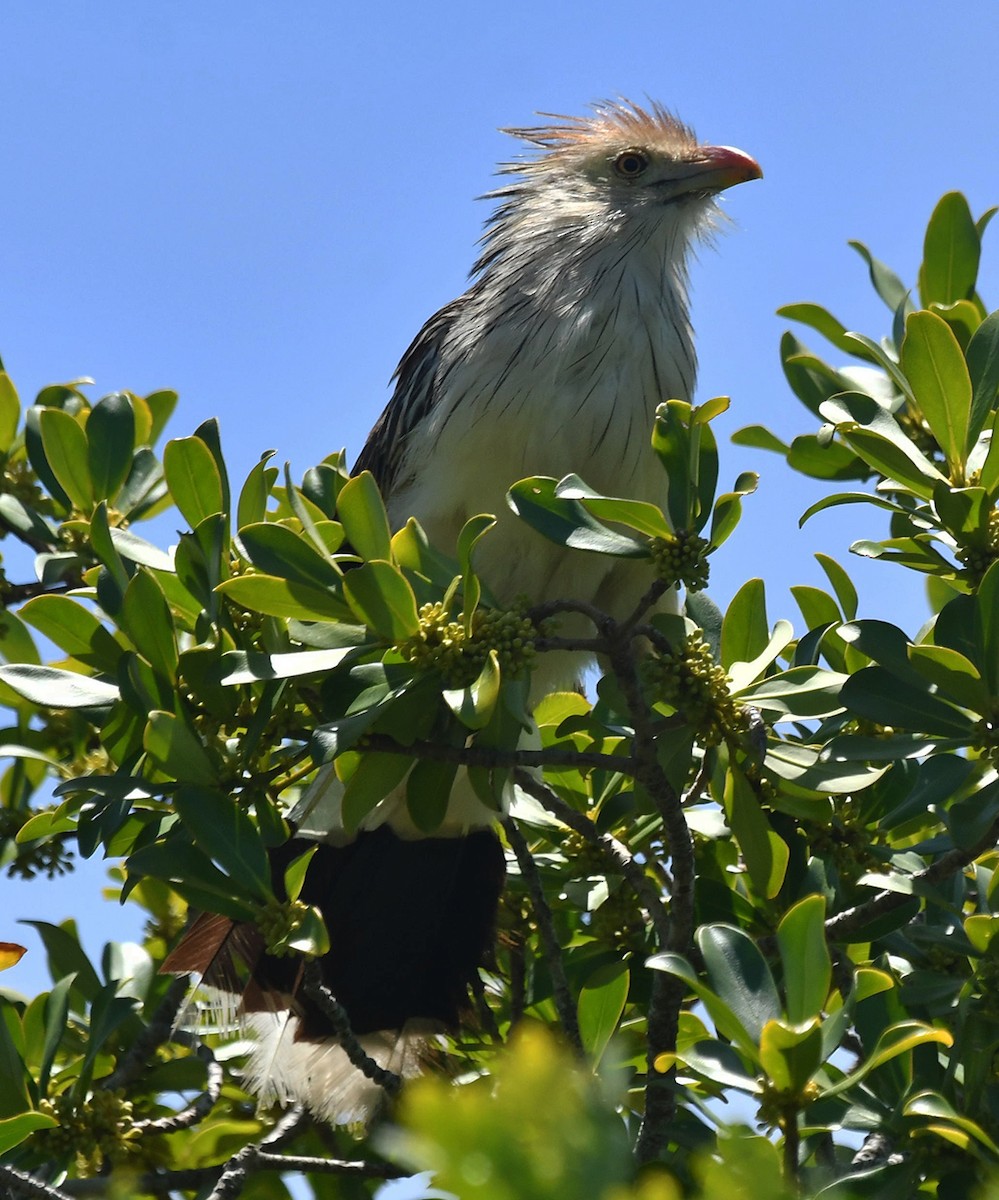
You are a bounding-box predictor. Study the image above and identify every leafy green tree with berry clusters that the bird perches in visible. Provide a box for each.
[0,193,999,1200]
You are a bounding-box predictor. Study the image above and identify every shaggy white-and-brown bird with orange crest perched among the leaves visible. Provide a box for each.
[166,100,762,1123]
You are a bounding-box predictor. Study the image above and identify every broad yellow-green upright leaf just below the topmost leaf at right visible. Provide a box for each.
[902,312,971,472]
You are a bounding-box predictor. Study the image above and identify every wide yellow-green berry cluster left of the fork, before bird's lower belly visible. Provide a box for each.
[399,602,539,688]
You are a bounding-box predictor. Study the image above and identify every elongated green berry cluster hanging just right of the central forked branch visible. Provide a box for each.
[644,630,747,746]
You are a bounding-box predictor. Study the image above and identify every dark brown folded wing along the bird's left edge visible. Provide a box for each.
[352,296,465,496]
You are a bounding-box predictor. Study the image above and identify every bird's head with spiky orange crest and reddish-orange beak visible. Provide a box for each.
[487,101,762,262]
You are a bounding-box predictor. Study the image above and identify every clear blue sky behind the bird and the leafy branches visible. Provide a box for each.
[0,0,999,1022]
